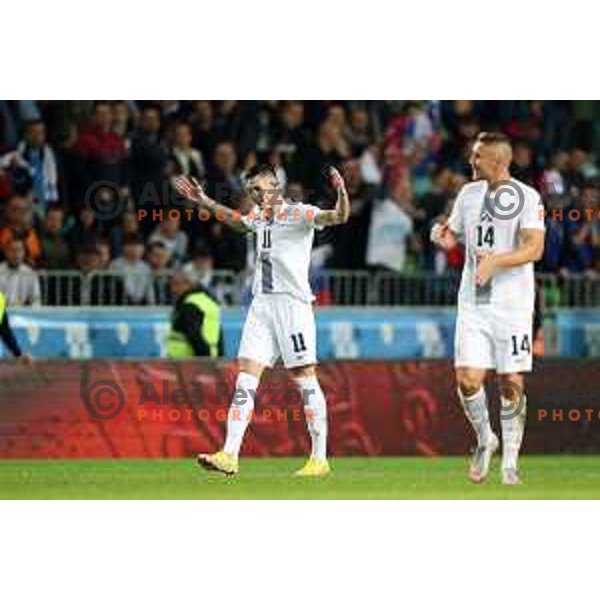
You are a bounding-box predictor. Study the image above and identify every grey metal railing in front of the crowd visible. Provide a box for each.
[8,269,600,309]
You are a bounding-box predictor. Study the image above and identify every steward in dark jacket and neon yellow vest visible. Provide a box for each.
[167,272,223,358]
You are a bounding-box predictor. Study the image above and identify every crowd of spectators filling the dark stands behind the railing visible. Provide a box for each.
[0,100,600,305]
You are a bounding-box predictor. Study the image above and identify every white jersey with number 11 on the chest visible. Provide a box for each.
[242,200,321,303]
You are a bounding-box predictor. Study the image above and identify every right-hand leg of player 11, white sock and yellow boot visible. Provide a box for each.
[290,365,331,477]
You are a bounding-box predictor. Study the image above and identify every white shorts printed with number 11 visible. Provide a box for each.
[238,294,317,368]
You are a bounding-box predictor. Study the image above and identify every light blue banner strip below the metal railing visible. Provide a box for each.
[0,306,600,360]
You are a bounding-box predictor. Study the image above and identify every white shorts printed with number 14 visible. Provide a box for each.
[454,306,533,373]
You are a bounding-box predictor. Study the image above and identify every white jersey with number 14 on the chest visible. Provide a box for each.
[448,179,544,311]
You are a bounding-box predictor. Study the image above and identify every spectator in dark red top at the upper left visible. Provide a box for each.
[73,101,127,185]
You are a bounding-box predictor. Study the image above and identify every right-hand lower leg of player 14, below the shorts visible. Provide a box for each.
[498,373,527,485]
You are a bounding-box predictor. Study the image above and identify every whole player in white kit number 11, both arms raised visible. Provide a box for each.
[174,165,350,477]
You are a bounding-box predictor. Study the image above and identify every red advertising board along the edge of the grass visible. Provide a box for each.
[0,359,600,458]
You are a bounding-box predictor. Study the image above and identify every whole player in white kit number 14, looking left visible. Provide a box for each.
[431,133,544,484]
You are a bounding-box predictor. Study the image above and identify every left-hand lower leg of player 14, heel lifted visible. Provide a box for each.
[456,367,498,483]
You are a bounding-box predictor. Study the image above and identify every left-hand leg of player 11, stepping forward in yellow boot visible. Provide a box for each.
[198,358,265,475]
